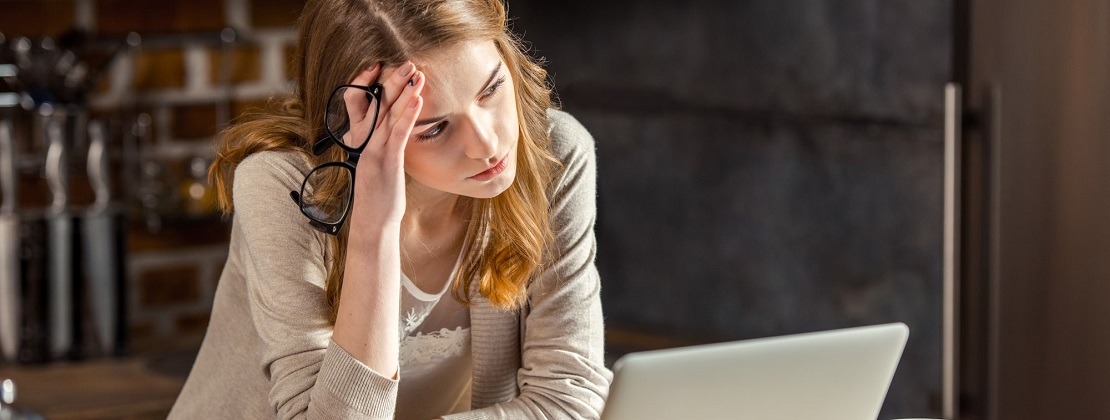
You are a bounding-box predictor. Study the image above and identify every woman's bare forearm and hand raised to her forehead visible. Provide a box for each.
[332,63,424,379]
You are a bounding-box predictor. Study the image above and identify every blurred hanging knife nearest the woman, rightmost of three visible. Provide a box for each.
[82,121,119,354]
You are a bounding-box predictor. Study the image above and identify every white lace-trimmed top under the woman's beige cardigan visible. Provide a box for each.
[395,252,471,420]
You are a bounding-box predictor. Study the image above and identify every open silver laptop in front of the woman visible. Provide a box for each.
[602,322,909,420]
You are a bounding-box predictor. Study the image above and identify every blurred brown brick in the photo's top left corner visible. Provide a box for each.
[0,0,75,38]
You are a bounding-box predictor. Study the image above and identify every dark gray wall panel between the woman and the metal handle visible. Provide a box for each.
[509,0,951,418]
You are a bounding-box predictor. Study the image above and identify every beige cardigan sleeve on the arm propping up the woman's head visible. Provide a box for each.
[232,151,397,419]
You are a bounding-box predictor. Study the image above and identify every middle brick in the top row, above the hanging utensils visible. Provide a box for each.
[97,0,227,34]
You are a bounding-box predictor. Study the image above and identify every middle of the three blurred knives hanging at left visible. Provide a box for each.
[40,107,73,359]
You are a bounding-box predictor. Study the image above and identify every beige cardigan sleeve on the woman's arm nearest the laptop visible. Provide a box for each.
[446,111,613,419]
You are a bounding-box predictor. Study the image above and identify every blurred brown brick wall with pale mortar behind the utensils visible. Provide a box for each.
[0,0,303,350]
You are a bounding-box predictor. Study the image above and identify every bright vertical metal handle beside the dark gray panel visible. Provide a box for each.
[941,83,963,420]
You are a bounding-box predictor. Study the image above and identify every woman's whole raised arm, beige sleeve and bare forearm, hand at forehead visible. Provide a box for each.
[233,63,423,419]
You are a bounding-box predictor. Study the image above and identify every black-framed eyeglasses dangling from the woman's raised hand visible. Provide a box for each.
[289,83,382,236]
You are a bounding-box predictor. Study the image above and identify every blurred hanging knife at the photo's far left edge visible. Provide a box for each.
[0,120,22,361]
